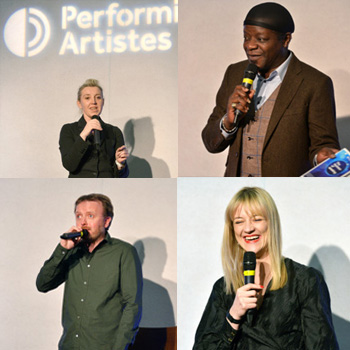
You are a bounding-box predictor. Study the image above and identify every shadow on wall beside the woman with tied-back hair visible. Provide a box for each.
[124,117,170,178]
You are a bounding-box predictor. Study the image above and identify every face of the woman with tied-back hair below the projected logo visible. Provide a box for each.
[77,86,104,120]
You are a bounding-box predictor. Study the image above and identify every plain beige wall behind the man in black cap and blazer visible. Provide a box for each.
[179,0,350,176]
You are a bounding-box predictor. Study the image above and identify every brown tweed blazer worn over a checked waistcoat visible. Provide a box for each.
[202,54,340,177]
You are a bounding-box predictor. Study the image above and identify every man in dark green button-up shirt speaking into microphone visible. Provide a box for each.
[36,194,142,350]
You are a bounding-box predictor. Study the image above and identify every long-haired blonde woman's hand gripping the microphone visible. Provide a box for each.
[230,283,264,321]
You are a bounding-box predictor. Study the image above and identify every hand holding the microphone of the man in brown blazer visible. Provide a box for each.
[224,85,255,129]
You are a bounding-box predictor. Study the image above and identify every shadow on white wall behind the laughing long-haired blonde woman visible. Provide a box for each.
[308,246,350,350]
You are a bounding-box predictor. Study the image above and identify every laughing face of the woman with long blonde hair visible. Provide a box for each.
[233,205,269,258]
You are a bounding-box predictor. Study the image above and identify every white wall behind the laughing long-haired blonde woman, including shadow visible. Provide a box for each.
[178,178,350,350]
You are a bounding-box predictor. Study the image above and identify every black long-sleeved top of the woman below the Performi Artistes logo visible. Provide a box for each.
[59,116,129,178]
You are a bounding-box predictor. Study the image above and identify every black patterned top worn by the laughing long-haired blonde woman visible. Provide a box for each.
[193,259,339,350]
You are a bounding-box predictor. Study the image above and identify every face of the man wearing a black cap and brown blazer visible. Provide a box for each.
[243,25,291,78]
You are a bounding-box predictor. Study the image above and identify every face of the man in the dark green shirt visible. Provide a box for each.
[75,201,111,243]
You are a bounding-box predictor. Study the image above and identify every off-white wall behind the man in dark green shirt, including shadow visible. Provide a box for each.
[0,179,177,350]
